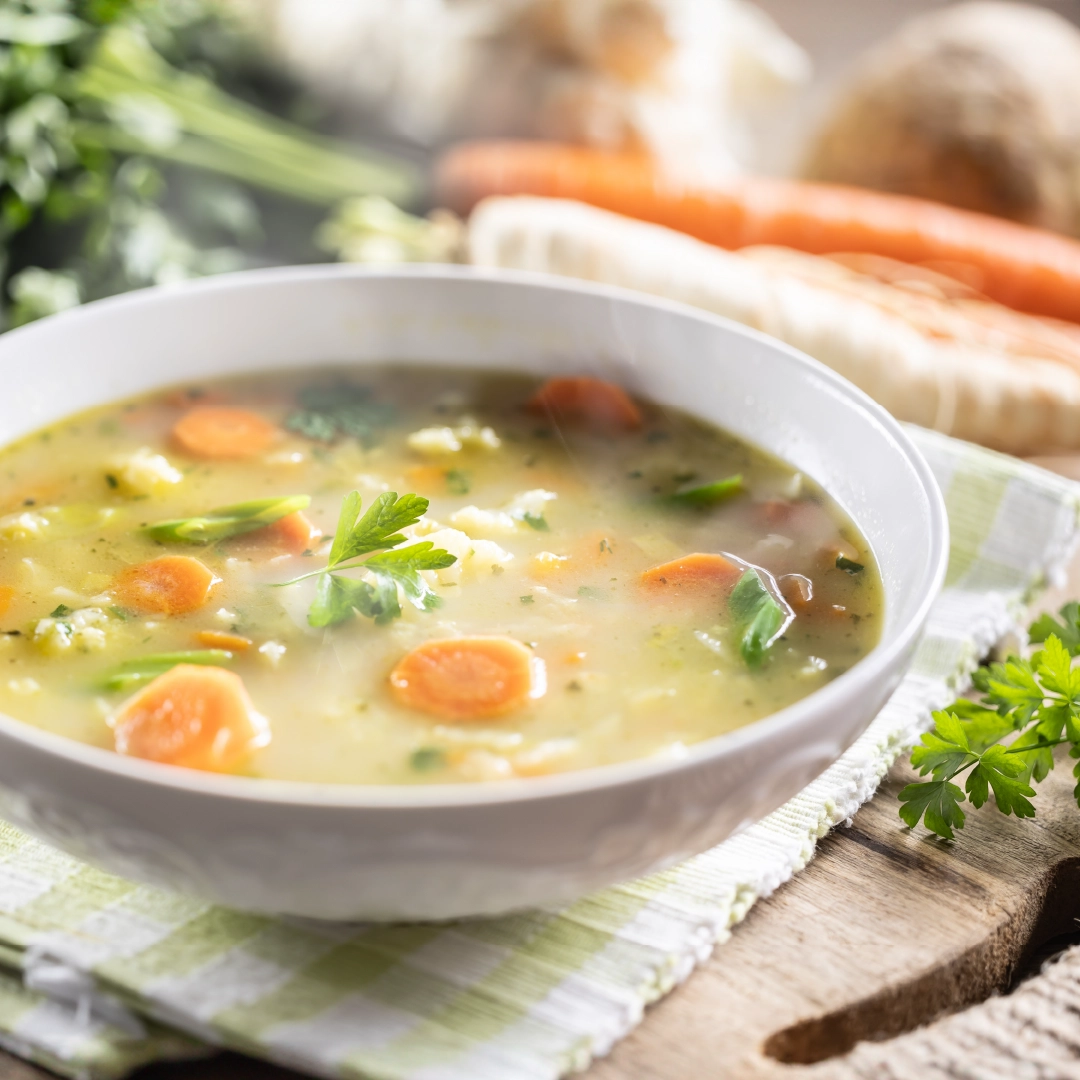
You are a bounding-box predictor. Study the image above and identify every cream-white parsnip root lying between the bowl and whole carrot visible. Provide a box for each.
[469,197,1080,454]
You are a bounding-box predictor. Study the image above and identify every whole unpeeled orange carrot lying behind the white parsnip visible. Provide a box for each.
[436,141,1080,322]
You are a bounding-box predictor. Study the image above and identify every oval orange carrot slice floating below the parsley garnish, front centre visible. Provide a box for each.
[390,636,546,720]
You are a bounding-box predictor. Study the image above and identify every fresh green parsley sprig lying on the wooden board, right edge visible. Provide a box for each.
[900,603,1080,840]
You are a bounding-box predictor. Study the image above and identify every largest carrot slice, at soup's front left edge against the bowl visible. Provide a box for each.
[111,664,270,772]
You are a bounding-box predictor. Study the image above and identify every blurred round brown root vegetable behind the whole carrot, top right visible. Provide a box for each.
[804,2,1080,235]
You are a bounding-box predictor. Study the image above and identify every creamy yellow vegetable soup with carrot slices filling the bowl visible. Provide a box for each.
[0,366,882,784]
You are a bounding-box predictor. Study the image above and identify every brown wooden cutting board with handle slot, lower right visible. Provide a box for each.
[0,459,1080,1080]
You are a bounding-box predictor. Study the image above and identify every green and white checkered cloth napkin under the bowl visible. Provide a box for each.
[0,429,1080,1080]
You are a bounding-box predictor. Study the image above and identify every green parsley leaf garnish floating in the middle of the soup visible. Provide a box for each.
[282,491,457,626]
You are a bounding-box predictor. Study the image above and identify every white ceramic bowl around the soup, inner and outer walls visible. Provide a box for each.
[0,267,948,919]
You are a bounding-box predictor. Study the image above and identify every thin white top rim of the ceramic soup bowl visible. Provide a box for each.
[0,264,949,811]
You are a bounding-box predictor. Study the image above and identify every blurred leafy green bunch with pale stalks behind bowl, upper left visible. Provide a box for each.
[0,0,420,325]
